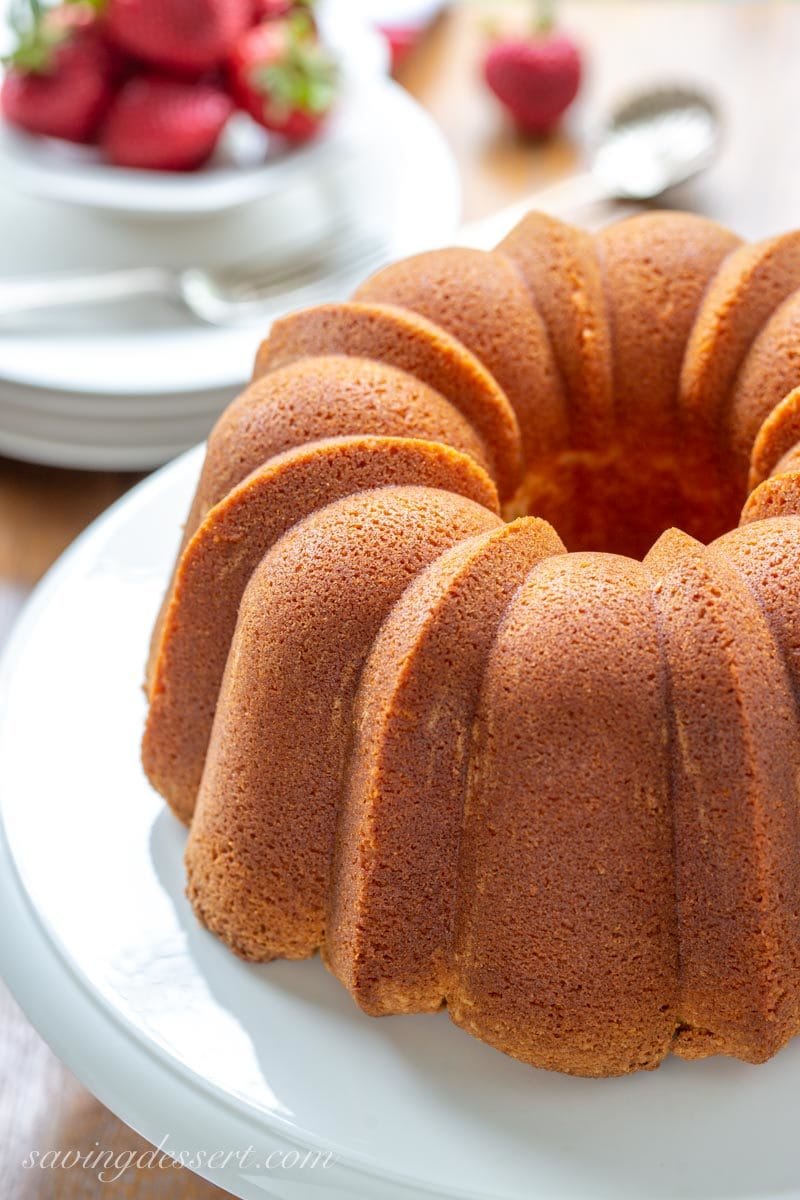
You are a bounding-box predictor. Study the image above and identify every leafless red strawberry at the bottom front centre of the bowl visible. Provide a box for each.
[102,76,233,170]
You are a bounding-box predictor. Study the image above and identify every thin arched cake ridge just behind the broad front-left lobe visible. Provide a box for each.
[143,437,497,821]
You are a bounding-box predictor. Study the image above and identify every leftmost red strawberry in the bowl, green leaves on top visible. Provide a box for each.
[0,4,119,142]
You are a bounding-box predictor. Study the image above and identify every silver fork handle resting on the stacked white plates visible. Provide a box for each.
[0,266,178,317]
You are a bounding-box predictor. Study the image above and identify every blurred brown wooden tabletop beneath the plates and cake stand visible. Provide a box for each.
[0,0,800,1200]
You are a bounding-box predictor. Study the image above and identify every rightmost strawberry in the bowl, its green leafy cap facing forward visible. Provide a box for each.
[229,12,337,142]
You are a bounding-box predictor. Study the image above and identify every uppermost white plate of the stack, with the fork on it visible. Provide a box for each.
[0,80,461,400]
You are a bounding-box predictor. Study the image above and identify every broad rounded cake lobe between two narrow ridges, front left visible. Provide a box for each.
[187,487,500,960]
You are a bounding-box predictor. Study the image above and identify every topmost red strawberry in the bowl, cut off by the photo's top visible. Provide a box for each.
[106,0,253,76]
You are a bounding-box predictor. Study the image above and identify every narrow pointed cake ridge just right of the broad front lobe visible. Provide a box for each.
[645,539,800,1062]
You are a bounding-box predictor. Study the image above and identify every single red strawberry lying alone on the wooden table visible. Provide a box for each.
[483,6,581,136]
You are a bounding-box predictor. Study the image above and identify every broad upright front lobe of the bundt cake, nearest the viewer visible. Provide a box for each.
[450,553,678,1075]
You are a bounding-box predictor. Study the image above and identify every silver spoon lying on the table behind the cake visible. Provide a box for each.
[458,86,721,248]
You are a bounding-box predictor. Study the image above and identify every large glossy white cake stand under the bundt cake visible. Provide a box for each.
[0,451,800,1200]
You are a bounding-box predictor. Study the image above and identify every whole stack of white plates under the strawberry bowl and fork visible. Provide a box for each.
[0,4,459,469]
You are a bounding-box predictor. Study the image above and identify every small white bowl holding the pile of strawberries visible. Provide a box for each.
[0,0,387,217]
